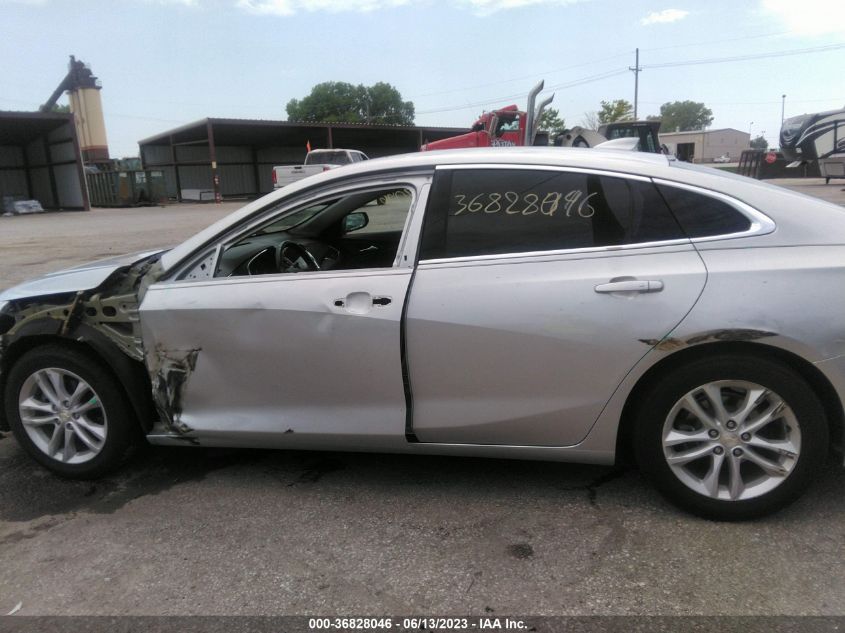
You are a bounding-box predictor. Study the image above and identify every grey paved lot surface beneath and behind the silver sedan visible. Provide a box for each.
[0,183,845,615]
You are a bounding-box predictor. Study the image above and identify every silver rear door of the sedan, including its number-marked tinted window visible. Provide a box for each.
[406,166,706,446]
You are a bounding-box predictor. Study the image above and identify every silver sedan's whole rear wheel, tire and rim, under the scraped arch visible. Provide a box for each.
[635,356,828,520]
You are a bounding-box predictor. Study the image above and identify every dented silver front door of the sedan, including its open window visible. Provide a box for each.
[141,178,428,447]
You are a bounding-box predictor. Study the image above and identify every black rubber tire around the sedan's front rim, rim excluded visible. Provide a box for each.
[3,345,138,479]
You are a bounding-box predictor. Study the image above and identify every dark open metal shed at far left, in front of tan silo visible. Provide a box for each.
[0,112,89,212]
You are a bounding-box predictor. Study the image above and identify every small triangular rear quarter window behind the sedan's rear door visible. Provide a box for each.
[657,185,751,238]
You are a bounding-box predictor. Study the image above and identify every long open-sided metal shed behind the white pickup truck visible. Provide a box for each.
[138,118,468,200]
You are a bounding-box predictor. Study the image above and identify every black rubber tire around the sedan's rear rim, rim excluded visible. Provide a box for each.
[633,355,828,521]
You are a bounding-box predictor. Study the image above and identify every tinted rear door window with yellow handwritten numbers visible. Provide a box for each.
[420,169,686,259]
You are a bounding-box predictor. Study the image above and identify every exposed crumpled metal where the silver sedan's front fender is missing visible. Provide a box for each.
[0,255,199,435]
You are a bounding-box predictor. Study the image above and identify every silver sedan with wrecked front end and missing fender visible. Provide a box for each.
[0,148,845,520]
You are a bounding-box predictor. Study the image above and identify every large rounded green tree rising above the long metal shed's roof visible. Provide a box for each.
[285,81,414,125]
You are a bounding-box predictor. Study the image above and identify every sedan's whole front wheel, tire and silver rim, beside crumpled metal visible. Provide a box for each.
[4,346,135,478]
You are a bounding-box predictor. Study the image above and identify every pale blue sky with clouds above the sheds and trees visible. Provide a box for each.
[0,0,845,157]
